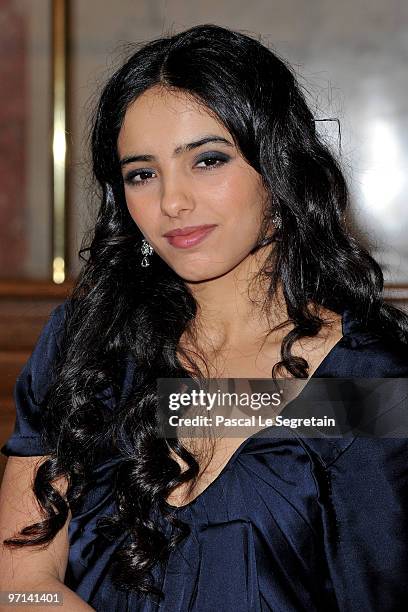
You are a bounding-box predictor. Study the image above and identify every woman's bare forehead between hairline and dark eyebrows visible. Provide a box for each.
[118,86,230,152]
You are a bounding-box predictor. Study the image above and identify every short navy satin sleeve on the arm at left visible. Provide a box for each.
[0,302,65,457]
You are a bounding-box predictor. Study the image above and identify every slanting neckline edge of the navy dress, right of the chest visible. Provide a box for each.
[163,309,359,512]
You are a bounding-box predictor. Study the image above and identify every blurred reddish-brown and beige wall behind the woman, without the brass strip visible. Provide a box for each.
[0,0,408,476]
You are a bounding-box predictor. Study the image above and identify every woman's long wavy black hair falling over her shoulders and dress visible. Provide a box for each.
[6,24,408,598]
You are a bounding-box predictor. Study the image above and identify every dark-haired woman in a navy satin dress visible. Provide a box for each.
[1,25,408,612]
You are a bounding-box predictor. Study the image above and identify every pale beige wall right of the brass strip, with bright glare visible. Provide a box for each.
[67,0,408,283]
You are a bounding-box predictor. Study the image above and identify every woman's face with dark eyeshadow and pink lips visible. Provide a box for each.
[118,87,266,281]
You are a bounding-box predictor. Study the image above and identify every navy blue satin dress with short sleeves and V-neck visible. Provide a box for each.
[1,305,408,612]
